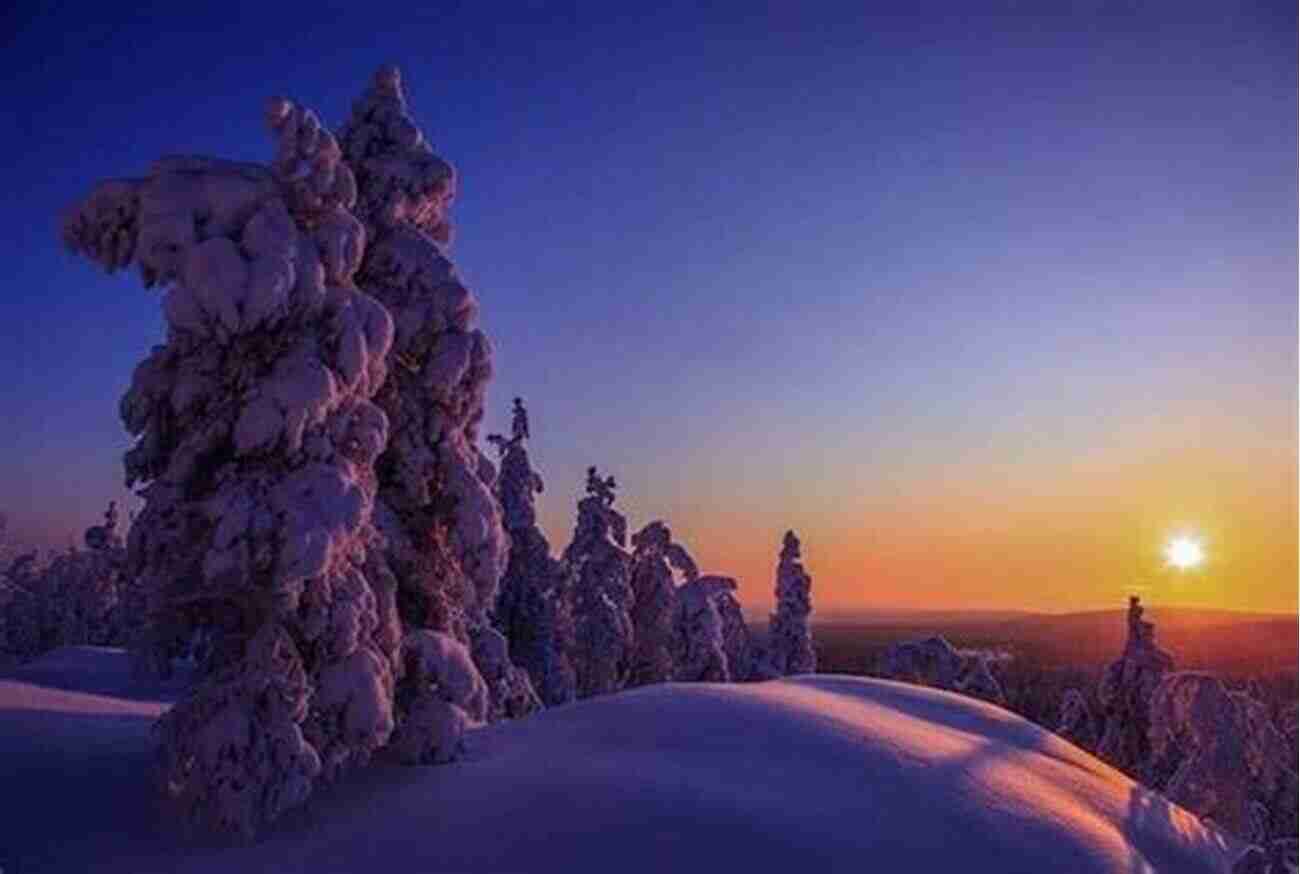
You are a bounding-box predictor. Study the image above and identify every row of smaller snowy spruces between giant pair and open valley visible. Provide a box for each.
[489,398,816,705]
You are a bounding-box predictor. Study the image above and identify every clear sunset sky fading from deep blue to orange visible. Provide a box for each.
[0,0,1297,610]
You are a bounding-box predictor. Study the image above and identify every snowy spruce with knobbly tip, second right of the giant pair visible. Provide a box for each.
[563,467,634,698]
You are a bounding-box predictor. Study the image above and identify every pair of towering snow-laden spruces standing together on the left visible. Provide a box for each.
[64,68,517,832]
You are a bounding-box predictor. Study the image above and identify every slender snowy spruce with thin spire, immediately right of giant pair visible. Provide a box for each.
[488,398,577,706]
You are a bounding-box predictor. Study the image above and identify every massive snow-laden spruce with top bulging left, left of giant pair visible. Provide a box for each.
[64,93,400,832]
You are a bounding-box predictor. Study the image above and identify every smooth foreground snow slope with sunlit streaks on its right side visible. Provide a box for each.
[0,648,1238,874]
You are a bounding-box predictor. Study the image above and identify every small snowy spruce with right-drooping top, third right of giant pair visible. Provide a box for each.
[629,520,699,685]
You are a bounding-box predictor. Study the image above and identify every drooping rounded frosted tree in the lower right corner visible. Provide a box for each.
[1148,671,1296,841]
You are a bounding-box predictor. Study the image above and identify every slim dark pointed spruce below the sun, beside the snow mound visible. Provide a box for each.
[1097,596,1174,778]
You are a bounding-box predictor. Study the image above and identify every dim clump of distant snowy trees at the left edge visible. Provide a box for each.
[0,502,140,662]
